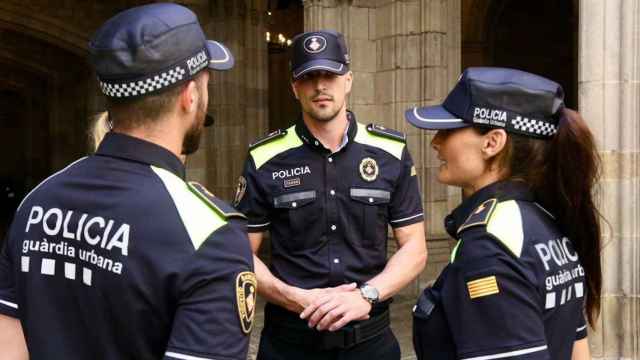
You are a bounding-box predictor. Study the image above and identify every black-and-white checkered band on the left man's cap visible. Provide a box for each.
[100,66,186,98]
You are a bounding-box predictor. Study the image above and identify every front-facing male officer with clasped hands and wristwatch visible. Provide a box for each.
[236,31,426,359]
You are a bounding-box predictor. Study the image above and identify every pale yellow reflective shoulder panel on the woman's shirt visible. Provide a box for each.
[487,200,524,257]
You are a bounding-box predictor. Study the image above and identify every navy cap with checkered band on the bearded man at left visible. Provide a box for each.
[89,3,234,99]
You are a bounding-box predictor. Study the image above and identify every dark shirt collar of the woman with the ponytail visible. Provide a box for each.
[444,180,534,239]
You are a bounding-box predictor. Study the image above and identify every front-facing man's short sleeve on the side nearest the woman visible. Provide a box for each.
[389,146,424,228]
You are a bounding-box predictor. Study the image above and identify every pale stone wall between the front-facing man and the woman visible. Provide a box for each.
[304,0,461,295]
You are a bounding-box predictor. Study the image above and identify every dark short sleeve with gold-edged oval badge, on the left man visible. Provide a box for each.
[165,222,257,360]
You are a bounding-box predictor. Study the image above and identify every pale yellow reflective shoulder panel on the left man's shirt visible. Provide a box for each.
[151,166,227,250]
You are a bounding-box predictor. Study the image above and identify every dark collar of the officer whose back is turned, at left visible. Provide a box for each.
[96,131,186,180]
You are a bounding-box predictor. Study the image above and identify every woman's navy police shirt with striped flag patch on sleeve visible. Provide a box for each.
[414,182,587,360]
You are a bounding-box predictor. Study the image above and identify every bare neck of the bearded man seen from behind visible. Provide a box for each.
[113,118,184,162]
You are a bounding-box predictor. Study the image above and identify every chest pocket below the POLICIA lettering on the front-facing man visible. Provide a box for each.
[273,190,321,250]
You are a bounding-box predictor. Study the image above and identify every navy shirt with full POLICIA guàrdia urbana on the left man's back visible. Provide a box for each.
[0,133,256,360]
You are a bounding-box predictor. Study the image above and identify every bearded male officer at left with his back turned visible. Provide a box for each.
[0,4,256,360]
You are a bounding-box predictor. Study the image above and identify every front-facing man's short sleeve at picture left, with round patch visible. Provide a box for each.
[234,155,271,232]
